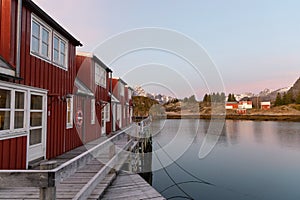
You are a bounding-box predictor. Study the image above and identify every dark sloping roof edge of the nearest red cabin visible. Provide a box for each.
[23,0,82,46]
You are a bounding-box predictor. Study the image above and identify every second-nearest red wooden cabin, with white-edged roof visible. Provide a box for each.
[75,53,112,138]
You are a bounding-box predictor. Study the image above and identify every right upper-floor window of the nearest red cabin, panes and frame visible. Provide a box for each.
[53,34,67,69]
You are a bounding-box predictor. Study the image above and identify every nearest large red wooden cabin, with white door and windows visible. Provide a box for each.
[0,0,82,169]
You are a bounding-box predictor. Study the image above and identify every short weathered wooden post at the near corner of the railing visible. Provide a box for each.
[40,161,57,200]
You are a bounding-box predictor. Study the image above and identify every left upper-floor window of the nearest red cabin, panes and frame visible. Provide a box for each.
[31,17,51,60]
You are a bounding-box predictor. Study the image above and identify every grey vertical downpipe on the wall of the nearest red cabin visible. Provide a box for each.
[16,0,22,77]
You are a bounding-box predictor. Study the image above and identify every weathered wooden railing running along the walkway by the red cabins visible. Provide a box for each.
[0,125,139,200]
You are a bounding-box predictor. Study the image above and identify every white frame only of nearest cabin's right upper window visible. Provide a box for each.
[52,31,69,70]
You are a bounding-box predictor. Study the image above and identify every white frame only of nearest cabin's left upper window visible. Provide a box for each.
[30,15,52,62]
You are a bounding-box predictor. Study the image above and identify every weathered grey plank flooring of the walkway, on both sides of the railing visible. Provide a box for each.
[0,126,164,200]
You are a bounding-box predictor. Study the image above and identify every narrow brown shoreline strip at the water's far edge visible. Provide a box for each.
[167,114,300,122]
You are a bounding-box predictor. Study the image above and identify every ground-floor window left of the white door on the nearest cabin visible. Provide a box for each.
[0,88,25,132]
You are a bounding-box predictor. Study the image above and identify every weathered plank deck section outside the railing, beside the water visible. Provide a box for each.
[101,172,165,200]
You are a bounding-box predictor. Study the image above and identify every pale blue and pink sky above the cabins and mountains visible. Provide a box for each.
[34,0,300,99]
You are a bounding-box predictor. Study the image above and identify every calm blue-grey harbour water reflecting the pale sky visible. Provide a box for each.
[148,120,300,200]
